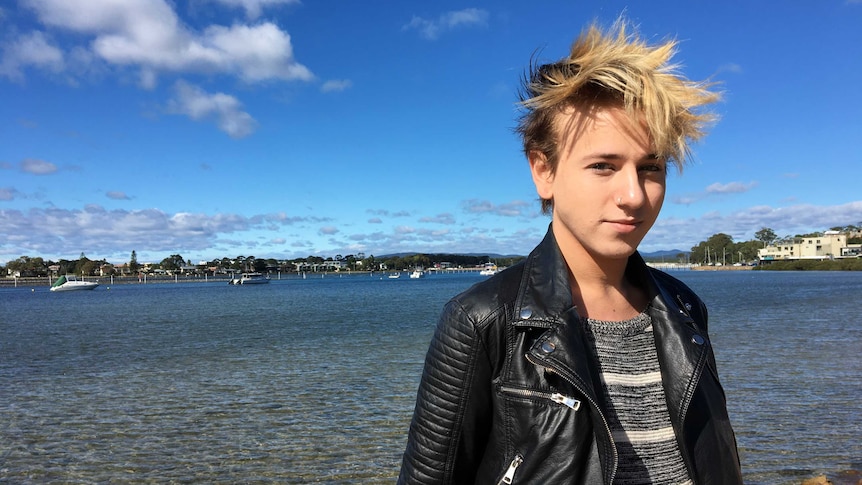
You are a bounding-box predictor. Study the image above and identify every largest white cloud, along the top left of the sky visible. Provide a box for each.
[25,0,314,87]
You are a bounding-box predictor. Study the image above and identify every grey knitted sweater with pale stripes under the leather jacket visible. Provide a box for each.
[584,311,692,485]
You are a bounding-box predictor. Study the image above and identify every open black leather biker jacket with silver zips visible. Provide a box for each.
[398,230,742,485]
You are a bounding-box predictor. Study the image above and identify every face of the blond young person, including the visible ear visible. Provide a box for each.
[530,108,667,263]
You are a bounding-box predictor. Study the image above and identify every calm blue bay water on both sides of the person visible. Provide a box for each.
[0,272,862,484]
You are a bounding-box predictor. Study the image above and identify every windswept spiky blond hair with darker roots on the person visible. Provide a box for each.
[517,18,720,212]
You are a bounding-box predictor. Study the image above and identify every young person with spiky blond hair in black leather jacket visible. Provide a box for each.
[399,20,742,484]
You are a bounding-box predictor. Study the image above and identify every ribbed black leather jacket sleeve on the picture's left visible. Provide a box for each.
[398,300,491,484]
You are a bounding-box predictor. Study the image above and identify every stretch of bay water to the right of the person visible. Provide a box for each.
[675,271,862,484]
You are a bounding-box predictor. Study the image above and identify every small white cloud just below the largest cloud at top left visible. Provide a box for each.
[168,81,257,138]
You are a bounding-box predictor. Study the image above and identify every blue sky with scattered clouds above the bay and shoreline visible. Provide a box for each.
[0,0,862,264]
